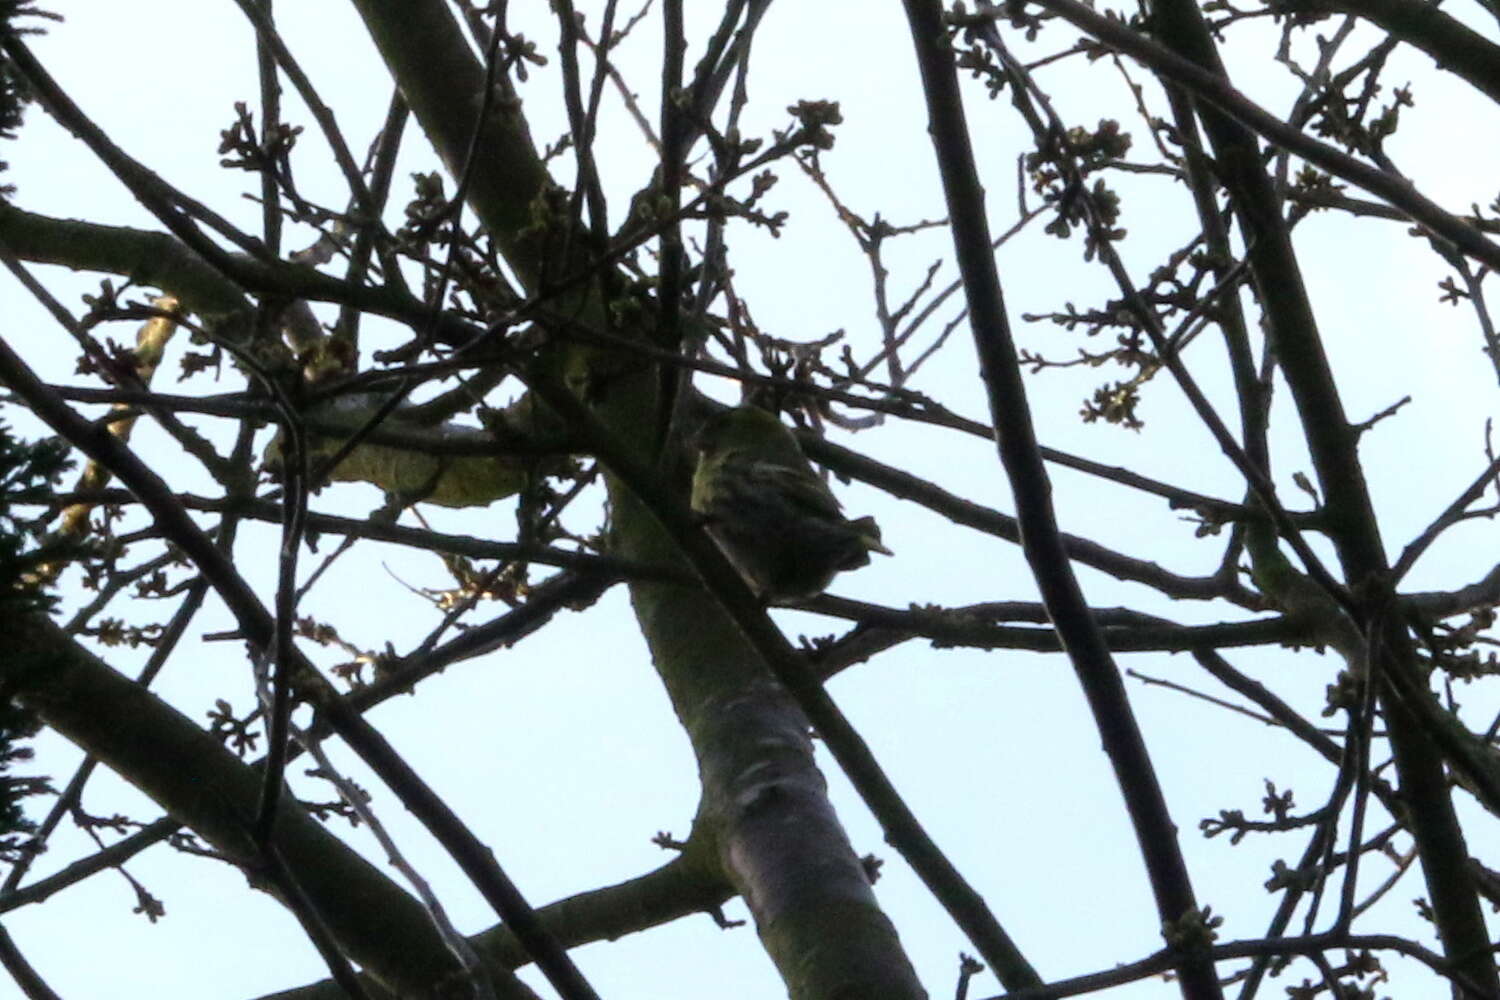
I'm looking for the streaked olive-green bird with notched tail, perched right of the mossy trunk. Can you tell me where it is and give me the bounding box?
[693,406,891,601]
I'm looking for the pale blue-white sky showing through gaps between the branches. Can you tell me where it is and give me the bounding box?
[0,0,1500,1000]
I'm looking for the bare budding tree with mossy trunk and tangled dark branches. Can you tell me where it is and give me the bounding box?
[0,0,1500,1000]
